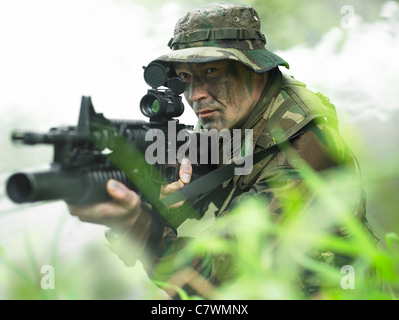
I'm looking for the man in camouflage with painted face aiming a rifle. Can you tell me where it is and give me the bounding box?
[69,3,376,296]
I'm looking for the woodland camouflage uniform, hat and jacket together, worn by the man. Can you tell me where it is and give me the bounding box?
[108,3,376,295]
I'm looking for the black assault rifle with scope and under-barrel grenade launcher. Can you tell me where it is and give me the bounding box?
[6,62,216,226]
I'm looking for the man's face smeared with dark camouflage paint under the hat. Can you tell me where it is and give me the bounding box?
[175,60,267,130]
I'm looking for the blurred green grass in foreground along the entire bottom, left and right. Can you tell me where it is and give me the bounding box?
[0,152,399,300]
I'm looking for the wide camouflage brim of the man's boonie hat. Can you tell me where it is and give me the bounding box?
[155,47,289,73]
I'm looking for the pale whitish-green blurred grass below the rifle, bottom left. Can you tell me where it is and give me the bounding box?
[0,222,159,300]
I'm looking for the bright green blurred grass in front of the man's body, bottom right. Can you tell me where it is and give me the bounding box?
[148,141,399,300]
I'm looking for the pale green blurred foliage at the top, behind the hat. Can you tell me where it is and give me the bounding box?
[132,0,386,50]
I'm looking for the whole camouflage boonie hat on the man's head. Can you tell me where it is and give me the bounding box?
[156,3,289,73]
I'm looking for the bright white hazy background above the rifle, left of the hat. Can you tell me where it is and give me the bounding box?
[0,0,195,128]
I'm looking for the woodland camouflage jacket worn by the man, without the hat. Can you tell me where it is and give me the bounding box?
[134,68,376,297]
